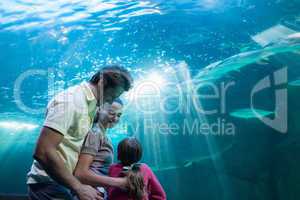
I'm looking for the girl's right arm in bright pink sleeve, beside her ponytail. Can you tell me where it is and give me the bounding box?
[146,165,167,200]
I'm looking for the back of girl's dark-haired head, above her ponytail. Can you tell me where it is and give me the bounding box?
[118,138,143,166]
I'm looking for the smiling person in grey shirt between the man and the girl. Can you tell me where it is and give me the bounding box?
[74,99,126,196]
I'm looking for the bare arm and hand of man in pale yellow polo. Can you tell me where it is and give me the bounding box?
[34,127,102,200]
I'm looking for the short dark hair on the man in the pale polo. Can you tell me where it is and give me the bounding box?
[90,65,133,91]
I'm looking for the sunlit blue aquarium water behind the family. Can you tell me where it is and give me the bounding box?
[0,0,300,200]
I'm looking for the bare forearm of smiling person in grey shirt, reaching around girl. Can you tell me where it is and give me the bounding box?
[74,153,127,188]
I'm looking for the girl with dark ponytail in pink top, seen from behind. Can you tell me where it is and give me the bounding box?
[108,138,166,200]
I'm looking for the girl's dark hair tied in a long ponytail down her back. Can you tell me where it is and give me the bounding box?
[118,138,145,200]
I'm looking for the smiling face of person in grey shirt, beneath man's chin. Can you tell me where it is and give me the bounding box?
[99,102,123,128]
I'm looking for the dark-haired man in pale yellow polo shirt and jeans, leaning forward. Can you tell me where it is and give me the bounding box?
[27,66,132,200]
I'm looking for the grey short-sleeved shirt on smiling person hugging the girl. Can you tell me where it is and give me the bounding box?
[81,124,113,175]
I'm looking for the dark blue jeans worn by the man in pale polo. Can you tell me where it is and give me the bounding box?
[28,182,73,200]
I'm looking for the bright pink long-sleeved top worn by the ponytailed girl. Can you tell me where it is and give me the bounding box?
[108,164,167,200]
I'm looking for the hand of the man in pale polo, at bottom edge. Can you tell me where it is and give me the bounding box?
[75,185,103,200]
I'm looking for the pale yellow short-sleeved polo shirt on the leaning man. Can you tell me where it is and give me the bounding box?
[27,82,97,184]
